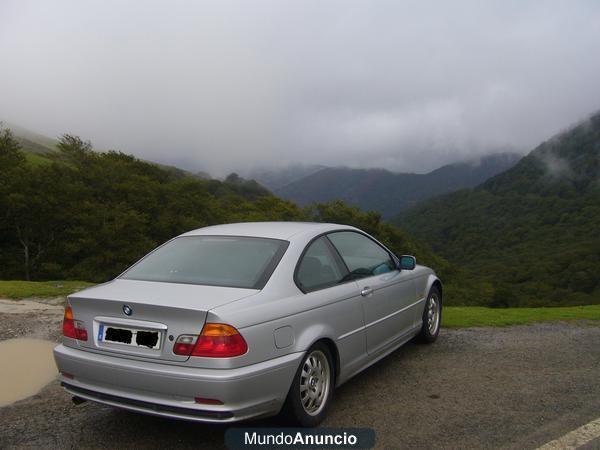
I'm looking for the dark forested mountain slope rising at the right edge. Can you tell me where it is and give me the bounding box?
[394,113,600,306]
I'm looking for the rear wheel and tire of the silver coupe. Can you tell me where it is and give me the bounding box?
[282,342,335,427]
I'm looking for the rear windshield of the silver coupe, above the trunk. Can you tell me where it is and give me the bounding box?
[121,236,288,289]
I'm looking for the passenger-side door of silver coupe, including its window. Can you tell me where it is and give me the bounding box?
[328,231,416,354]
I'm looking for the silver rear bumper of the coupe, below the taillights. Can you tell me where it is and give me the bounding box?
[54,345,303,422]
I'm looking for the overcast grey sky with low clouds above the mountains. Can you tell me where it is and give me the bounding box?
[0,0,600,175]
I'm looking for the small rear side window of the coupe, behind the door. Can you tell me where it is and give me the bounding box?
[296,237,342,292]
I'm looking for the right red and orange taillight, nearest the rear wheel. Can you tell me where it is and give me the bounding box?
[173,323,248,358]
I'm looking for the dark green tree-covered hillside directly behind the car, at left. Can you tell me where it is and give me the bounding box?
[0,125,448,282]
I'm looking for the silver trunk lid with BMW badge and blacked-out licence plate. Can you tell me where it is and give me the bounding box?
[68,279,259,361]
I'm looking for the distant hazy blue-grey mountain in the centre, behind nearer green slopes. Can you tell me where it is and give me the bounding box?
[268,153,520,218]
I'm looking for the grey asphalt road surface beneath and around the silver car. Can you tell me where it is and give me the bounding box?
[0,304,600,449]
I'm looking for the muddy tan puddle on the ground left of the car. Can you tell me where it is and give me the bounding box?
[0,339,58,406]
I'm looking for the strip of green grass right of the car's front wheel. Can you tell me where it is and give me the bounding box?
[442,305,600,328]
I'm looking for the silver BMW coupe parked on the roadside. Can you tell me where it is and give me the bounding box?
[54,222,442,426]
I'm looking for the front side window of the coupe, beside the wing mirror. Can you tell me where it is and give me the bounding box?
[328,231,395,279]
